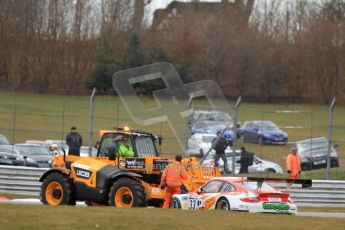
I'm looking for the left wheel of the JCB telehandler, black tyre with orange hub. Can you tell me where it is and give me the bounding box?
[40,173,75,206]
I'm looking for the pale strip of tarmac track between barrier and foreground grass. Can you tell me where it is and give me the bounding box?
[0,199,345,218]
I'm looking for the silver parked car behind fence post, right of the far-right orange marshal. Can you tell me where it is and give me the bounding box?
[296,137,339,170]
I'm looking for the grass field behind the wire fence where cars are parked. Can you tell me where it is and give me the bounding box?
[0,92,345,179]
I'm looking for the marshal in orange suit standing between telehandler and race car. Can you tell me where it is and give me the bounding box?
[161,155,188,208]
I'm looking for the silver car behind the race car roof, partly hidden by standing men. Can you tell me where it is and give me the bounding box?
[202,150,283,174]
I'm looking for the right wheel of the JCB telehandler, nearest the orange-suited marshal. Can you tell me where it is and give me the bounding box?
[108,177,147,208]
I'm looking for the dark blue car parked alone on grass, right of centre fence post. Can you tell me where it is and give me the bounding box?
[239,121,288,145]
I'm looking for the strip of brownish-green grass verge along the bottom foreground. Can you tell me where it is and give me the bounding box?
[0,204,345,230]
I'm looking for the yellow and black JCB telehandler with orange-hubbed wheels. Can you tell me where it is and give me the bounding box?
[40,128,220,207]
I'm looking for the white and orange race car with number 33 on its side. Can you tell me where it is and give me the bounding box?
[170,177,311,215]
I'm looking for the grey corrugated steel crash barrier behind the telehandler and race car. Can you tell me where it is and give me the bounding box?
[0,166,345,207]
